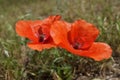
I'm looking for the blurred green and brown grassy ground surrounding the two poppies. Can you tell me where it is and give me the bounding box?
[0,0,120,80]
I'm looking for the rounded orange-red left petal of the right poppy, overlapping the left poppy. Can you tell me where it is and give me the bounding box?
[50,21,69,44]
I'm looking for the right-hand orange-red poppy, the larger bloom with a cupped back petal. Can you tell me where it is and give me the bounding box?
[50,20,112,61]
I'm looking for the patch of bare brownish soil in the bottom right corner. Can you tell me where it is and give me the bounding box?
[74,56,120,80]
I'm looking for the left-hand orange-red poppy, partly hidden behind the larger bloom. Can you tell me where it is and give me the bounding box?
[16,15,61,51]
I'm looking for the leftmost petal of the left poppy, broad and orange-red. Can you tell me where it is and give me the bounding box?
[16,20,38,42]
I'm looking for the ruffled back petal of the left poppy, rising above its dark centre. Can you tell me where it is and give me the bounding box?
[33,15,61,40]
